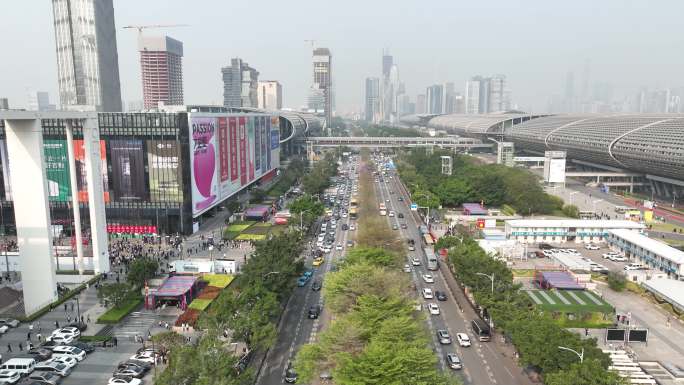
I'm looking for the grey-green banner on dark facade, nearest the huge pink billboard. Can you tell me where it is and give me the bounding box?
[147,140,183,202]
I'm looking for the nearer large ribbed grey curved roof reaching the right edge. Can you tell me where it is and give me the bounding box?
[505,114,684,180]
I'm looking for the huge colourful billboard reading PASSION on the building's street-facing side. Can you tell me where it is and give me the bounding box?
[187,113,280,217]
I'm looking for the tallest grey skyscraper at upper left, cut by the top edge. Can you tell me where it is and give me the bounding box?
[52,0,121,111]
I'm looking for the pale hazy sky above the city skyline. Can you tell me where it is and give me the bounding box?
[0,0,684,112]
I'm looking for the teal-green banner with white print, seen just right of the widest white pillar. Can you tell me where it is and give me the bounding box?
[43,139,71,202]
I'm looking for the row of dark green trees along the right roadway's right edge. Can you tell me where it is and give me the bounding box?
[440,234,624,385]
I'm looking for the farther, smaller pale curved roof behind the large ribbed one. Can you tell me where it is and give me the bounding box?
[428,111,543,136]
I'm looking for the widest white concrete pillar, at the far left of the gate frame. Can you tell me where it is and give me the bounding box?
[5,118,57,314]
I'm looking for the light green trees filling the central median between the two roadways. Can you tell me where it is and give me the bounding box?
[295,153,459,385]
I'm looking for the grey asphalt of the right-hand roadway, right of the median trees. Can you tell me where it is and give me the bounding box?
[376,157,532,385]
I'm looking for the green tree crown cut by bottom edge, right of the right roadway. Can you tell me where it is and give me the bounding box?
[544,359,627,385]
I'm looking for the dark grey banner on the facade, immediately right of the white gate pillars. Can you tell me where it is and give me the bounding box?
[109,139,147,202]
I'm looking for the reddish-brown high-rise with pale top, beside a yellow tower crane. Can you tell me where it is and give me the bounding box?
[138,35,183,109]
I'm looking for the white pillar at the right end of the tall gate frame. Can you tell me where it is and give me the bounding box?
[82,117,109,274]
